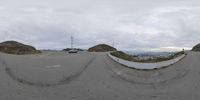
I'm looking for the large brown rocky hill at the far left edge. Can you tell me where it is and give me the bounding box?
[0,41,40,55]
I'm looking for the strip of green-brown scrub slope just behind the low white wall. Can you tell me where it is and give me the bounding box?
[111,51,185,63]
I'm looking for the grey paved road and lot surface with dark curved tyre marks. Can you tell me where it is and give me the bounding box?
[0,52,200,100]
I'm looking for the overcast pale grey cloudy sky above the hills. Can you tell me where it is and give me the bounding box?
[0,0,200,50]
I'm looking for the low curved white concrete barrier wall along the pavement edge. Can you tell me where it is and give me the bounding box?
[108,53,186,70]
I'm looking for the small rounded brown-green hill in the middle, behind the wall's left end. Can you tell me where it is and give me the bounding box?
[88,44,117,52]
